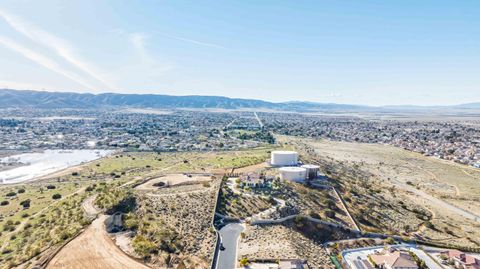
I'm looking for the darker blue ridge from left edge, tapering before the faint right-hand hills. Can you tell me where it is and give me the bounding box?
[0,89,368,111]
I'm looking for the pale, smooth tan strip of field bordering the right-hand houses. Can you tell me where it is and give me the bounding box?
[311,140,480,203]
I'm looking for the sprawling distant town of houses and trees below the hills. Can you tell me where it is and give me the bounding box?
[0,109,480,168]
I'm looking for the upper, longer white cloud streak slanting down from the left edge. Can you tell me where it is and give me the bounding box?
[0,9,116,89]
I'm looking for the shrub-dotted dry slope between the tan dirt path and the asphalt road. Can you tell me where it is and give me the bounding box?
[134,182,218,268]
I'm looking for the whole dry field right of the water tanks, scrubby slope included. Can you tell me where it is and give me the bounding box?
[283,137,480,246]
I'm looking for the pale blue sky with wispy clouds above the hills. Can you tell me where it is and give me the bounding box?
[0,0,480,105]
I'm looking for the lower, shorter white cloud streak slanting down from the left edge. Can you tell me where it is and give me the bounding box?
[0,36,95,90]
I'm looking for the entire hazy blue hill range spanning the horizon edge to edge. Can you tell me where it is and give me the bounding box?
[0,89,480,114]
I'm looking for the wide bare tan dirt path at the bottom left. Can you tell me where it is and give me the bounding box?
[46,215,150,269]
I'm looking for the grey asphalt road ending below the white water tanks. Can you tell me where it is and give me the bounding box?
[217,223,245,269]
